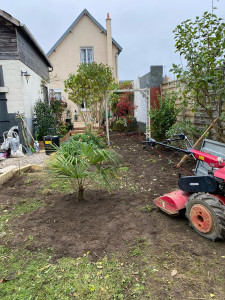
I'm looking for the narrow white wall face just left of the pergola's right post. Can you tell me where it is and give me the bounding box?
[133,78,146,124]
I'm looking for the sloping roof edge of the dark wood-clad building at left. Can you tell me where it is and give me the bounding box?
[0,9,53,68]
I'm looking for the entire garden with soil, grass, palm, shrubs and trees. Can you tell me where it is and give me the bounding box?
[0,7,225,300]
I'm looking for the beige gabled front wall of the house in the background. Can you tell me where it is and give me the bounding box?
[49,15,118,112]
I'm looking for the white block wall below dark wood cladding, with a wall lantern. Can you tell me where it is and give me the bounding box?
[0,60,46,139]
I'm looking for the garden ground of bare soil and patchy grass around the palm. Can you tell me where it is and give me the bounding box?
[0,133,225,299]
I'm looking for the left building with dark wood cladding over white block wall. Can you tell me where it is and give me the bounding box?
[0,10,52,142]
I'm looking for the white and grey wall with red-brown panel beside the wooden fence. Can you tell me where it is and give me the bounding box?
[133,66,163,131]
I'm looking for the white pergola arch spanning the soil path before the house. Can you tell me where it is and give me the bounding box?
[105,88,151,145]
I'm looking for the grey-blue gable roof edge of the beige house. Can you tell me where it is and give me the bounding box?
[47,8,123,56]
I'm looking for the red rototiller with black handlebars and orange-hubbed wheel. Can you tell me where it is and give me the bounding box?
[143,133,225,241]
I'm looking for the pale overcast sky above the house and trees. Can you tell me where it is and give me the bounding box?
[0,0,225,80]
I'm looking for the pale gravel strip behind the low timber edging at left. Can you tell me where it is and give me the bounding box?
[0,152,48,169]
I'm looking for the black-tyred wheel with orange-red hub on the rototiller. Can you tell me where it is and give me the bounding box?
[185,193,225,241]
